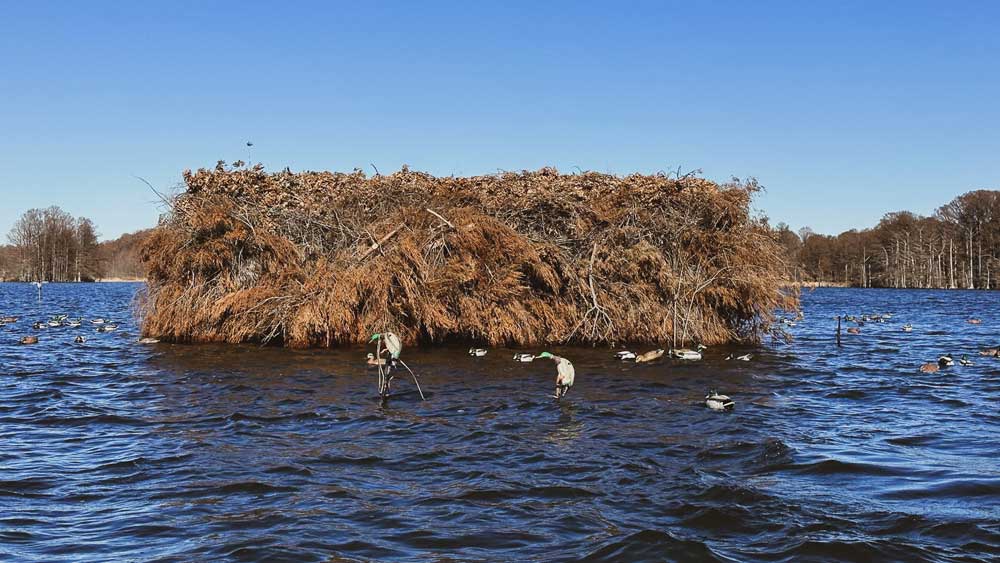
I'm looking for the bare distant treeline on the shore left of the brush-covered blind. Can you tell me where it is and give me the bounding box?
[0,206,148,282]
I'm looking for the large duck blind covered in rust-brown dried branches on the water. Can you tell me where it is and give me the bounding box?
[141,162,797,347]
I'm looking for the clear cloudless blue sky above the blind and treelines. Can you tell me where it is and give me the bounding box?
[0,0,1000,238]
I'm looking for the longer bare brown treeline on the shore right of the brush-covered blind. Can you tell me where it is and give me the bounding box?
[776,190,1000,289]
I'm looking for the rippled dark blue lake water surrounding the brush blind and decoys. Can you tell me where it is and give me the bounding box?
[0,284,1000,562]
